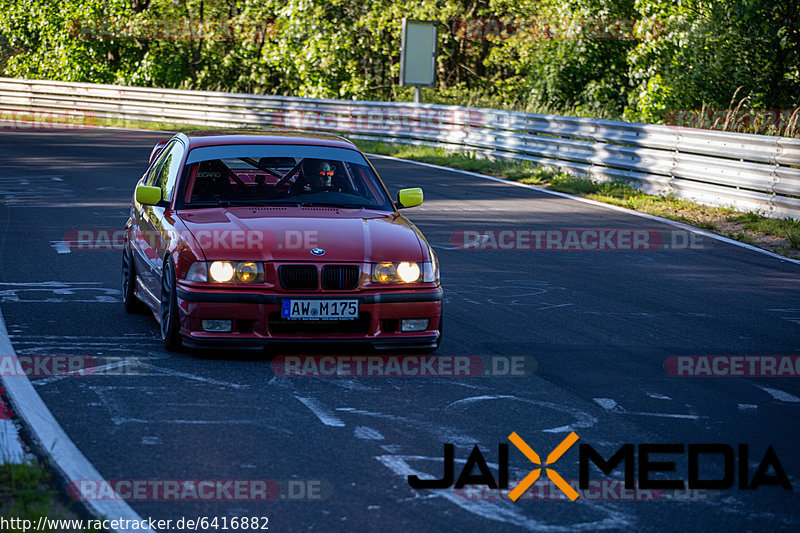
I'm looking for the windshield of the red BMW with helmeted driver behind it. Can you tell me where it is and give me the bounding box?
[181,145,394,211]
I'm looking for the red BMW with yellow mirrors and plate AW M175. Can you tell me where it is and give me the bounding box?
[122,131,442,350]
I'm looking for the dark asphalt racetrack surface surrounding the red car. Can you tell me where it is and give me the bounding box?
[0,125,800,531]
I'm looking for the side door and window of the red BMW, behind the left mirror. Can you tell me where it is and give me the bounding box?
[135,139,185,299]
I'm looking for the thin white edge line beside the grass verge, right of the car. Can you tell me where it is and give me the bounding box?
[366,154,800,265]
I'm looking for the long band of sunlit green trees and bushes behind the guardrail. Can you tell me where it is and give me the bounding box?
[0,0,800,129]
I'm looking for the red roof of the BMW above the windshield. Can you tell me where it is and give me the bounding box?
[181,129,355,150]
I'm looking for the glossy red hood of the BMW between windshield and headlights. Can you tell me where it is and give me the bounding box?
[177,207,428,263]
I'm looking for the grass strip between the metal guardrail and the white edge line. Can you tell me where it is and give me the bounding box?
[356,141,800,259]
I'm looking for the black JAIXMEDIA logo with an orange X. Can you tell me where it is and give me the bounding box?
[408,432,792,501]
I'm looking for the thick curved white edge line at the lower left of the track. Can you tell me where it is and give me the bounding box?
[0,306,154,533]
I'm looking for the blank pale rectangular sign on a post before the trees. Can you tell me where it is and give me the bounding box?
[400,18,438,102]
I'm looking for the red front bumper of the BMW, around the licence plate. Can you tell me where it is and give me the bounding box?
[177,282,442,348]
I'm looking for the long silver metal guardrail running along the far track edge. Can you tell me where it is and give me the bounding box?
[0,78,800,218]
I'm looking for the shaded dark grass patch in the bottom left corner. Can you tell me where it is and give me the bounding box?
[0,462,95,533]
